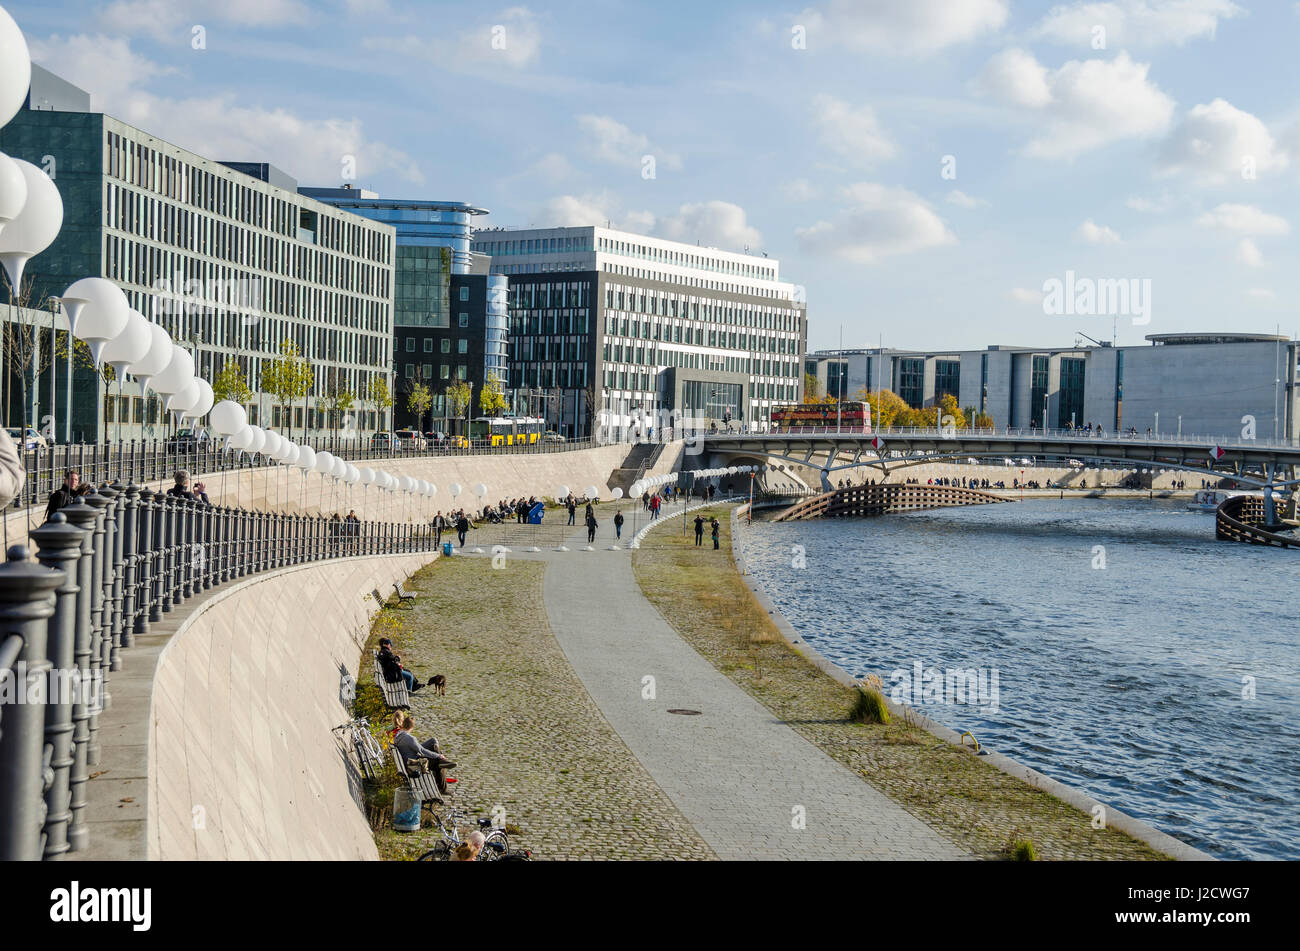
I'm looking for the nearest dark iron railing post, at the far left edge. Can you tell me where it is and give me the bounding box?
[0,544,64,861]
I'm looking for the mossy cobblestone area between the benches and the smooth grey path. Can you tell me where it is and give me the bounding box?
[385,552,714,860]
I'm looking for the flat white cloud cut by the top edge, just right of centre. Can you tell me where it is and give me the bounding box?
[800,0,1008,56]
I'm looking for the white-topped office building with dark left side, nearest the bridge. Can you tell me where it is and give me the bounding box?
[473,226,807,437]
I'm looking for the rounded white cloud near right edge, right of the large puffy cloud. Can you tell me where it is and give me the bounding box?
[1160,99,1287,183]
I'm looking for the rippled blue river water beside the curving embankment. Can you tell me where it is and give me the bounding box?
[745,499,1300,859]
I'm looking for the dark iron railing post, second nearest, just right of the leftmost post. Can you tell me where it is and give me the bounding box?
[31,512,90,859]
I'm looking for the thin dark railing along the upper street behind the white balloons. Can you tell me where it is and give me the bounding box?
[12,438,605,508]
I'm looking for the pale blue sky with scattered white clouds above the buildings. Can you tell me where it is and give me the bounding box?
[10,0,1300,349]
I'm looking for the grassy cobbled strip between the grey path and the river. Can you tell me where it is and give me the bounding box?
[633,505,1167,860]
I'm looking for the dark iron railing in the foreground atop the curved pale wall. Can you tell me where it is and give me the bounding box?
[0,483,434,860]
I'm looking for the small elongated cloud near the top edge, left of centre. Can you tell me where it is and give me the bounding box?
[361,6,542,75]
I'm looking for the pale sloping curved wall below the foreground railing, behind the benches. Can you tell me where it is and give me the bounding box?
[147,553,430,860]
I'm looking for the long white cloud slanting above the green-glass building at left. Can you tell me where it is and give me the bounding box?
[31,36,424,184]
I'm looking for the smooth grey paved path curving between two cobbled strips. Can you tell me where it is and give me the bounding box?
[460,521,969,859]
